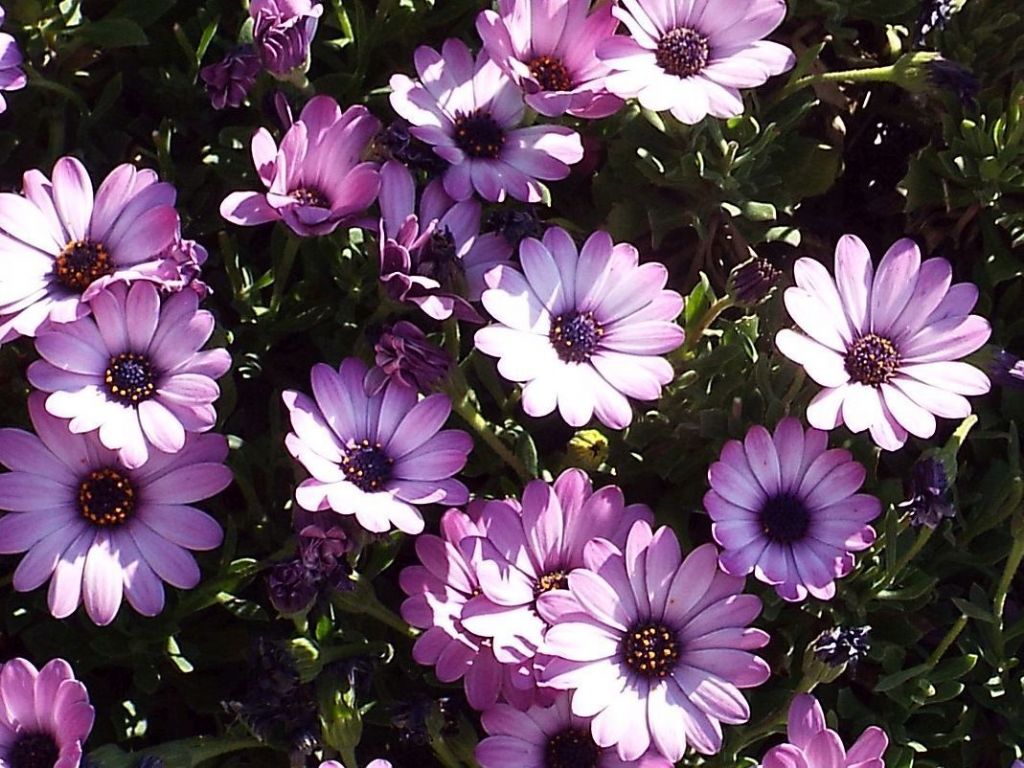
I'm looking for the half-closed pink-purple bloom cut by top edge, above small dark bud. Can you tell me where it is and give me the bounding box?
[249,0,324,78]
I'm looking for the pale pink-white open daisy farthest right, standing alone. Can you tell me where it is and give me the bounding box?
[775,234,992,451]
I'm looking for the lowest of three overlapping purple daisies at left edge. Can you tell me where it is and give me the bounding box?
[0,393,231,625]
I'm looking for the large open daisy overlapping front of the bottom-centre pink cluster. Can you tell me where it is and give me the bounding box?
[538,521,771,763]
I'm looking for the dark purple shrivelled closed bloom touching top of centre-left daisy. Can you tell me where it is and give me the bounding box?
[367,321,452,393]
